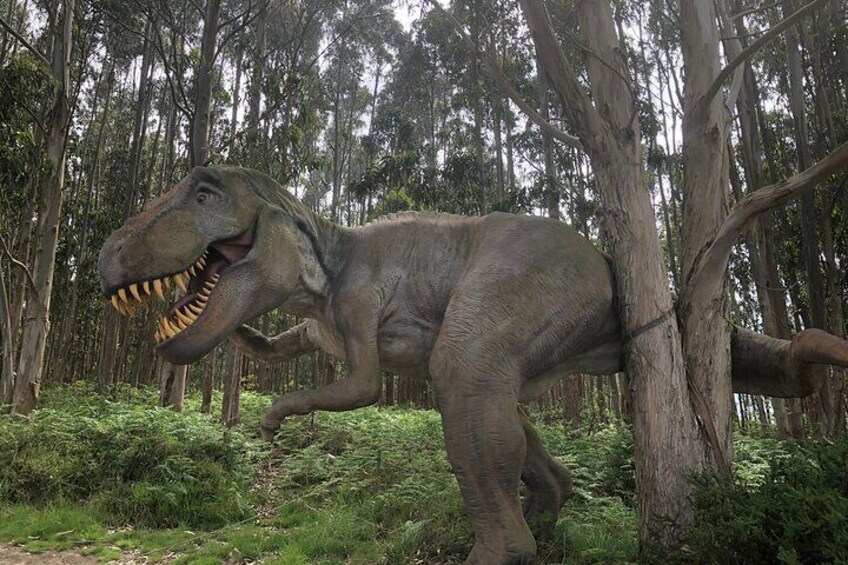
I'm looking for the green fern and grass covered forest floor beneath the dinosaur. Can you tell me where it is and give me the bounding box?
[0,385,848,565]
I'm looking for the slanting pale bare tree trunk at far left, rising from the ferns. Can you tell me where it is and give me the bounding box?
[12,0,74,414]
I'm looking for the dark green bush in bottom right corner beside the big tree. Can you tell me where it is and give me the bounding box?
[683,437,848,563]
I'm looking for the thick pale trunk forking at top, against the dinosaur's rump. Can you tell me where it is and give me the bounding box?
[522,0,704,546]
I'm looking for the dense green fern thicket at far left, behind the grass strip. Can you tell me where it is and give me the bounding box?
[0,387,255,527]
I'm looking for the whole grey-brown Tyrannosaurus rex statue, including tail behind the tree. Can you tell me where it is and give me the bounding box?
[100,167,848,564]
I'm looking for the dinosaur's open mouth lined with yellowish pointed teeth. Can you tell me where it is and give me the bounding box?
[104,228,253,344]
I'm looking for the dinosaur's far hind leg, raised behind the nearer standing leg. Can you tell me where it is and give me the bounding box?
[519,408,571,538]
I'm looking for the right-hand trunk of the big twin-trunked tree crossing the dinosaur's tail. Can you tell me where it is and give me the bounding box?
[679,0,733,473]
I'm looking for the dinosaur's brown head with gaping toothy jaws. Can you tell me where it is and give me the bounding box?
[100,167,301,364]
